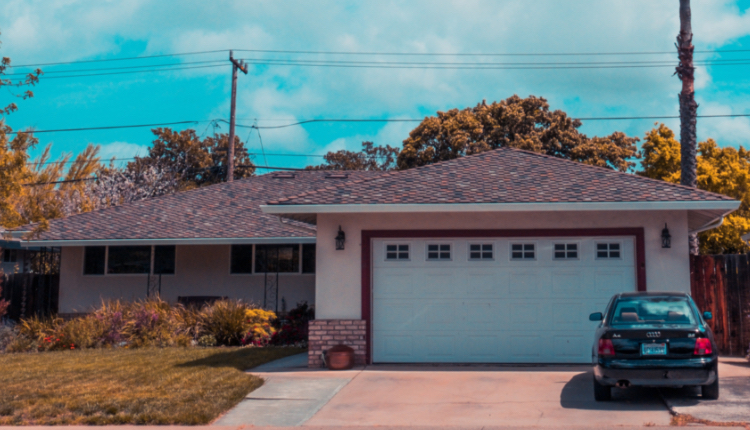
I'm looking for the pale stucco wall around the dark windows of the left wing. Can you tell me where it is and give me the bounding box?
[59,245,315,313]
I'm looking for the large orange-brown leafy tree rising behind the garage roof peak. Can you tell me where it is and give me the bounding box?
[397,95,639,171]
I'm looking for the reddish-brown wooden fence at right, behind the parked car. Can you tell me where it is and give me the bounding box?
[690,254,750,356]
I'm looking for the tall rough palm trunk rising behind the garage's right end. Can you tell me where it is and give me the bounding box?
[675,0,698,255]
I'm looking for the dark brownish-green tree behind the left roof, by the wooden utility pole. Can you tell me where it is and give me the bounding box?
[127,128,255,190]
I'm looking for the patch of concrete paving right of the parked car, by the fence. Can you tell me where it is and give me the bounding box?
[662,358,750,423]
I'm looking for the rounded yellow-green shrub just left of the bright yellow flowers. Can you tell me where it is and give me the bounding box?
[200,300,252,346]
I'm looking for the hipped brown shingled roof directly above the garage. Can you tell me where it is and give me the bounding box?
[268,148,733,207]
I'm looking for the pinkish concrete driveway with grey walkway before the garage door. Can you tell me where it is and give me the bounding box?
[214,358,671,428]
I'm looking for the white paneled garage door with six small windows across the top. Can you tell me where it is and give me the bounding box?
[372,237,636,363]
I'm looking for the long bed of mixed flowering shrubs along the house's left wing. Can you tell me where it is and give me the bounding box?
[0,298,312,352]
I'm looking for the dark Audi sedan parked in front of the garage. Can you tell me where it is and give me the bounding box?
[589,293,719,401]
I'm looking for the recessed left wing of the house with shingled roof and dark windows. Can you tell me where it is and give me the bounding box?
[16,171,382,315]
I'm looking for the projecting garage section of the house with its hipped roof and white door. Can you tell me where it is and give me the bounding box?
[262,148,739,366]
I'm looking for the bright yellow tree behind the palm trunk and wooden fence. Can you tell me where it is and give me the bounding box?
[638,124,750,254]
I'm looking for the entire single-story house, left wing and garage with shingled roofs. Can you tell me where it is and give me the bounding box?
[13,148,739,366]
